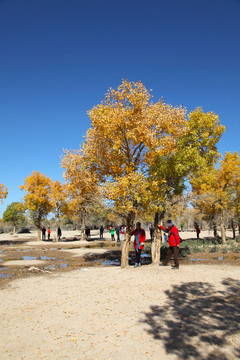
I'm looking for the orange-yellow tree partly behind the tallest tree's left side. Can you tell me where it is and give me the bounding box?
[61,149,101,240]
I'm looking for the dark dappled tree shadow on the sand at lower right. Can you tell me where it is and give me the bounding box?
[142,278,240,360]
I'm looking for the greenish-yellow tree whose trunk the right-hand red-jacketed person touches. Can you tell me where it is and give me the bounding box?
[149,108,225,263]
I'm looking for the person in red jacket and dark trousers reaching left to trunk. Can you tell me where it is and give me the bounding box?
[159,220,180,269]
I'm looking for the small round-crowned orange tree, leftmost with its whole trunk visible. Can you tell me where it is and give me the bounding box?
[19,171,53,240]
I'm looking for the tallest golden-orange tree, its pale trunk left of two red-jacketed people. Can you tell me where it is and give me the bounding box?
[84,81,186,267]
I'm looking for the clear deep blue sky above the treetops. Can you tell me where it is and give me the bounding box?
[0,0,240,217]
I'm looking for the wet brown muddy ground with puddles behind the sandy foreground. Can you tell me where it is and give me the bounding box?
[0,239,240,287]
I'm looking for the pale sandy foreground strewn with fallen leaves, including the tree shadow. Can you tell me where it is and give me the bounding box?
[0,265,240,360]
